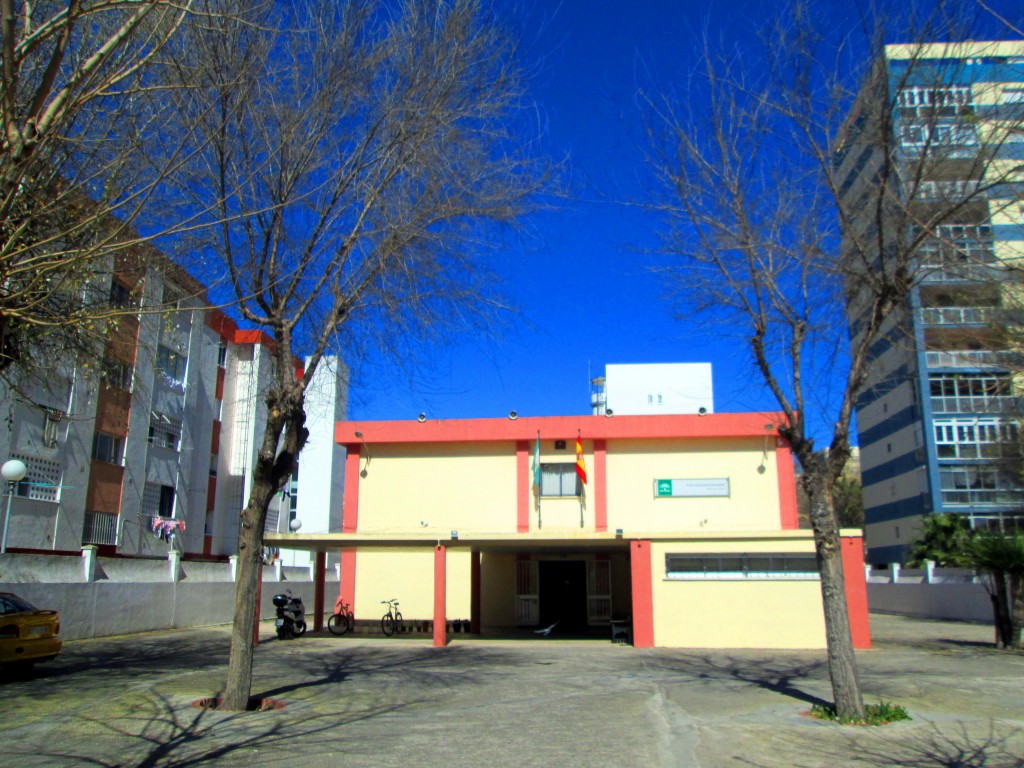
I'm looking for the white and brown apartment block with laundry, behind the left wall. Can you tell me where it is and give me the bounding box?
[0,260,347,564]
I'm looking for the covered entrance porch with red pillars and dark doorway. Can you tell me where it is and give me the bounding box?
[267,531,653,647]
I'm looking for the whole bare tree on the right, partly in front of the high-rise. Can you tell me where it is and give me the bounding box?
[644,3,1021,720]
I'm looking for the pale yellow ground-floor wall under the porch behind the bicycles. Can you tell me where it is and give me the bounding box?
[355,547,471,622]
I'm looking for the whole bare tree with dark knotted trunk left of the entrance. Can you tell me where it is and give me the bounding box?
[160,0,549,710]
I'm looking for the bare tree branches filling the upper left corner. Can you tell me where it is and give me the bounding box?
[0,0,208,387]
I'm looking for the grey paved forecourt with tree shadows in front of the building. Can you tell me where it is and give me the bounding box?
[0,615,1024,768]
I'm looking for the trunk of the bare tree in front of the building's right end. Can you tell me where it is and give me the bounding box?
[804,473,864,720]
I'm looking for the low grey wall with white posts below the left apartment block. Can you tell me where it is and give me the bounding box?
[0,547,338,640]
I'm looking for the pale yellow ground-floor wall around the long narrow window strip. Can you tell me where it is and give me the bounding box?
[651,540,825,648]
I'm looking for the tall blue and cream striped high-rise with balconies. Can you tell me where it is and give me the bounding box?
[837,42,1024,564]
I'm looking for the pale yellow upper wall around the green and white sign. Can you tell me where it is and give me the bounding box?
[607,437,780,538]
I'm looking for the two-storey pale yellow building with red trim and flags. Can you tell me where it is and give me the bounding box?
[267,414,870,648]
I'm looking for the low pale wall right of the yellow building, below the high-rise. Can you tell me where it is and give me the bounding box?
[865,563,992,622]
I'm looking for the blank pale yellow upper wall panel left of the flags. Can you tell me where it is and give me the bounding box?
[358,443,516,539]
